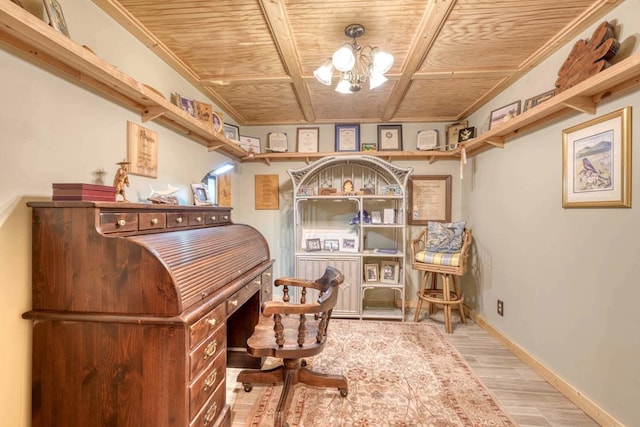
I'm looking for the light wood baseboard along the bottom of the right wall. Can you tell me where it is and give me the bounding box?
[465,306,624,427]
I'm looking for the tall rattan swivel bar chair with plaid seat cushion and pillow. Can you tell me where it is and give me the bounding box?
[411,223,473,334]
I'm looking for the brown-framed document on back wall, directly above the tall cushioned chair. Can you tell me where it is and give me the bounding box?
[408,175,451,225]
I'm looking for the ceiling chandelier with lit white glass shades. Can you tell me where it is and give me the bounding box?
[313,24,393,94]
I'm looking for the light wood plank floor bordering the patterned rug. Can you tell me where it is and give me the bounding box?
[227,313,599,427]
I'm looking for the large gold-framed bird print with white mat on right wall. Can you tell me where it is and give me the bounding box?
[562,107,631,208]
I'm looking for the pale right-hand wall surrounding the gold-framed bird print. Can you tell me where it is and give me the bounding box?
[462,0,640,426]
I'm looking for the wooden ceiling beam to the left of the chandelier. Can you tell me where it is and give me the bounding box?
[259,0,316,123]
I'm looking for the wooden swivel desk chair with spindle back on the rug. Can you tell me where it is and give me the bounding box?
[237,267,348,427]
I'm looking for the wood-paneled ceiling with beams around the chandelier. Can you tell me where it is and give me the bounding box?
[94,0,623,125]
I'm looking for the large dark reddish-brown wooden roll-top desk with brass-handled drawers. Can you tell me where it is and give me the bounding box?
[23,202,272,427]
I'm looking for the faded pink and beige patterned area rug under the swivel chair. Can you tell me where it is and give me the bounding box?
[249,319,516,427]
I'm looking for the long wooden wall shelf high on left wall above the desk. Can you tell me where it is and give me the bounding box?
[0,1,247,160]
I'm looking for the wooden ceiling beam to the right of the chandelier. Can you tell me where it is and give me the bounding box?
[382,0,457,122]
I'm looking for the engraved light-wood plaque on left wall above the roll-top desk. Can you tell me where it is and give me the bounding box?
[127,122,158,178]
